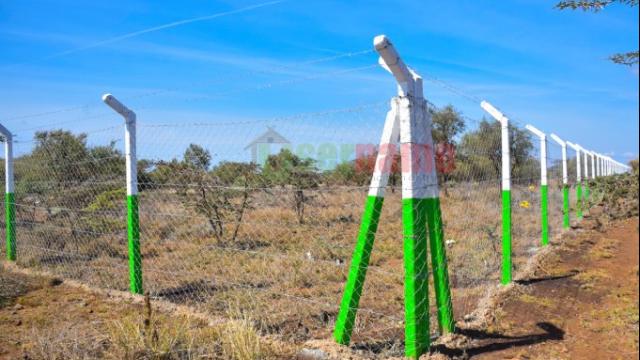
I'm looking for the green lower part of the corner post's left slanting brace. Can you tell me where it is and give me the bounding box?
[333,196,384,345]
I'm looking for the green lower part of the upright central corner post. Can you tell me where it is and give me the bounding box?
[402,199,430,359]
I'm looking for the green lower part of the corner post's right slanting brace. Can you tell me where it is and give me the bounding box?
[424,198,455,334]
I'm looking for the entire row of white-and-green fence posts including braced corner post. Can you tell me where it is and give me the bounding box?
[0,35,629,358]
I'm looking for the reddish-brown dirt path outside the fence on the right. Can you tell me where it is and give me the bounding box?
[449,217,639,359]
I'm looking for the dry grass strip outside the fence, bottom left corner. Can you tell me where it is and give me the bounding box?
[0,265,295,360]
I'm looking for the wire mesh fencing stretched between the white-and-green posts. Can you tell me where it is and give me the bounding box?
[0,66,596,354]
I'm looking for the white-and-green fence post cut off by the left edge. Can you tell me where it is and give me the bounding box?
[0,125,16,261]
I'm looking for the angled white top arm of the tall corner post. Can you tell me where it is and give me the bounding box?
[373,35,423,98]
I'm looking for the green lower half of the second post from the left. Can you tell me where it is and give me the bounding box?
[127,195,143,294]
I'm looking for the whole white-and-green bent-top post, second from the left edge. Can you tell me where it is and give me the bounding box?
[102,94,143,294]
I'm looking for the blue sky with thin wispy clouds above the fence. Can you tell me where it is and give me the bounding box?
[0,0,639,162]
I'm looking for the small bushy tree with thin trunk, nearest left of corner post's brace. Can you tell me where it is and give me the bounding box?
[262,149,320,224]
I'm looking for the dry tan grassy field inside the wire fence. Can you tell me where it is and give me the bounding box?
[2,181,576,357]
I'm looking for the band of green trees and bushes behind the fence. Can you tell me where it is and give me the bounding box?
[0,115,539,248]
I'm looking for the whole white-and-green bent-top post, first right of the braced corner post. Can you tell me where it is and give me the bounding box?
[480,101,513,285]
